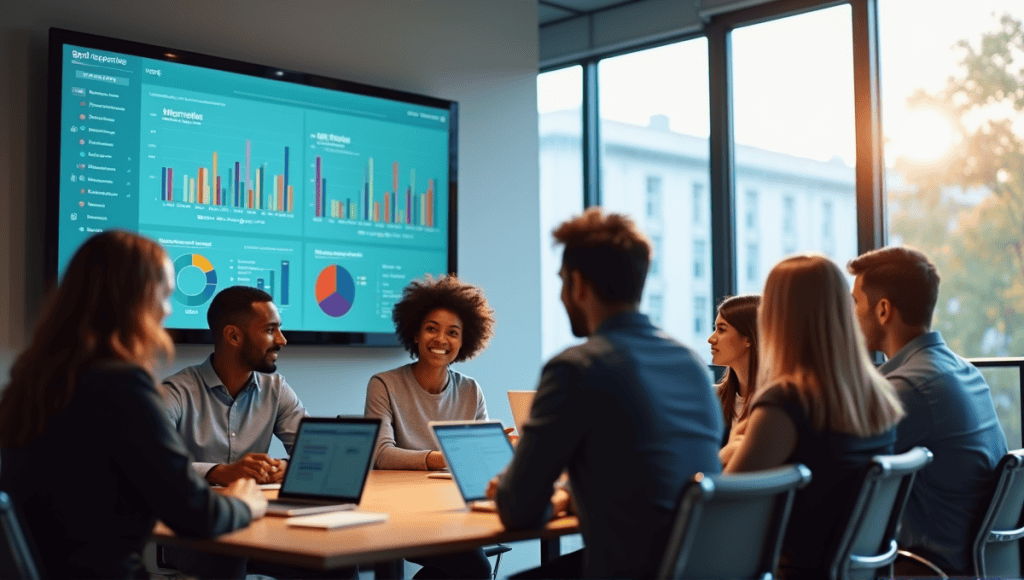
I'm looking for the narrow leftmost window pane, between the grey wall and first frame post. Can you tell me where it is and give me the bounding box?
[537,67,583,359]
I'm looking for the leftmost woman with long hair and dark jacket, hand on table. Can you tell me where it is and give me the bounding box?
[0,231,266,578]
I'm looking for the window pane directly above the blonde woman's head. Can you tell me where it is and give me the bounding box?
[732,0,860,293]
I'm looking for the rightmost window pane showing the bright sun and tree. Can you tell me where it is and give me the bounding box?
[879,0,1024,444]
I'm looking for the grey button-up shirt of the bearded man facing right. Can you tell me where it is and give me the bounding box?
[161,355,309,478]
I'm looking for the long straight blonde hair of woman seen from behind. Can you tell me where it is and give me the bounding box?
[757,254,903,437]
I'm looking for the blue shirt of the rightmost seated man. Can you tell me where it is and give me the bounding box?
[879,332,1007,573]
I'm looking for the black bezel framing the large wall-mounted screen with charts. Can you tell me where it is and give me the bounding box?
[44,28,459,346]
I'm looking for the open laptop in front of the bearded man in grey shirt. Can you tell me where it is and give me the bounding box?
[266,417,381,515]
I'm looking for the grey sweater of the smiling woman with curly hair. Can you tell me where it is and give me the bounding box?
[364,363,487,469]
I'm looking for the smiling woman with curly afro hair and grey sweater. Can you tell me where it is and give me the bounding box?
[365,275,495,579]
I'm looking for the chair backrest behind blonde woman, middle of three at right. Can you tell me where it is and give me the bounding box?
[829,447,932,580]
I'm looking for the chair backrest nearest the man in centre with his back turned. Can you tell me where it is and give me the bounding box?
[657,464,811,580]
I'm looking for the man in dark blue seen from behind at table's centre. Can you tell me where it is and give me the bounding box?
[488,208,722,578]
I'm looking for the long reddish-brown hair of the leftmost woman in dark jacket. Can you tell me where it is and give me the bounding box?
[0,231,174,448]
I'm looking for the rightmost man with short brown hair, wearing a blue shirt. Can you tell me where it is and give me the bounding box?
[847,247,1007,574]
